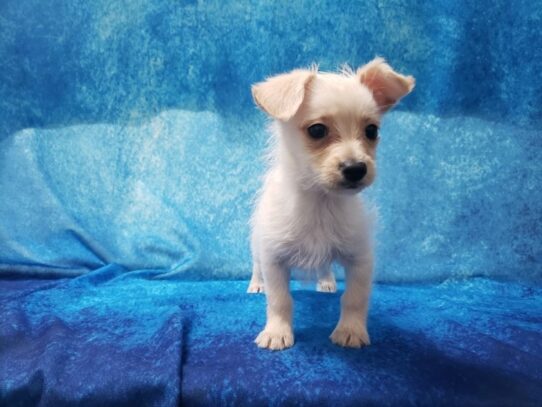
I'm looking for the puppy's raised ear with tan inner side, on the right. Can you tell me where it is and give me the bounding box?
[356,58,415,112]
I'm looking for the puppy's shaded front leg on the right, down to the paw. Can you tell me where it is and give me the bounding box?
[330,259,373,348]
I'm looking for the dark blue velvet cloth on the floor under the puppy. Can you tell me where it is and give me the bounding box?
[0,266,542,406]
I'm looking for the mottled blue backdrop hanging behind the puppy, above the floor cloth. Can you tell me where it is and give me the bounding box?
[0,0,542,281]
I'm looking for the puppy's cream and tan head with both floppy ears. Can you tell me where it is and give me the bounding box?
[252,58,414,192]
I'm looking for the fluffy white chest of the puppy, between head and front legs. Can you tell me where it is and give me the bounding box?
[253,171,365,269]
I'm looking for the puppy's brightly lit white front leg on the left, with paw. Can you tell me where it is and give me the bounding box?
[255,262,294,350]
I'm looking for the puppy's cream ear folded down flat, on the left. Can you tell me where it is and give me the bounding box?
[252,69,316,121]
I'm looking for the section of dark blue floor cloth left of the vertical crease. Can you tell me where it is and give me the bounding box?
[0,265,190,406]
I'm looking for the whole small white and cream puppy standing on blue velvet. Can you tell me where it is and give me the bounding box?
[248,58,414,350]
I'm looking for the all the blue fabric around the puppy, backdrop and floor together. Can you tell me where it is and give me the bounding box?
[0,0,542,406]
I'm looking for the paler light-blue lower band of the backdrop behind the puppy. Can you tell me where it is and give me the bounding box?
[0,110,542,281]
